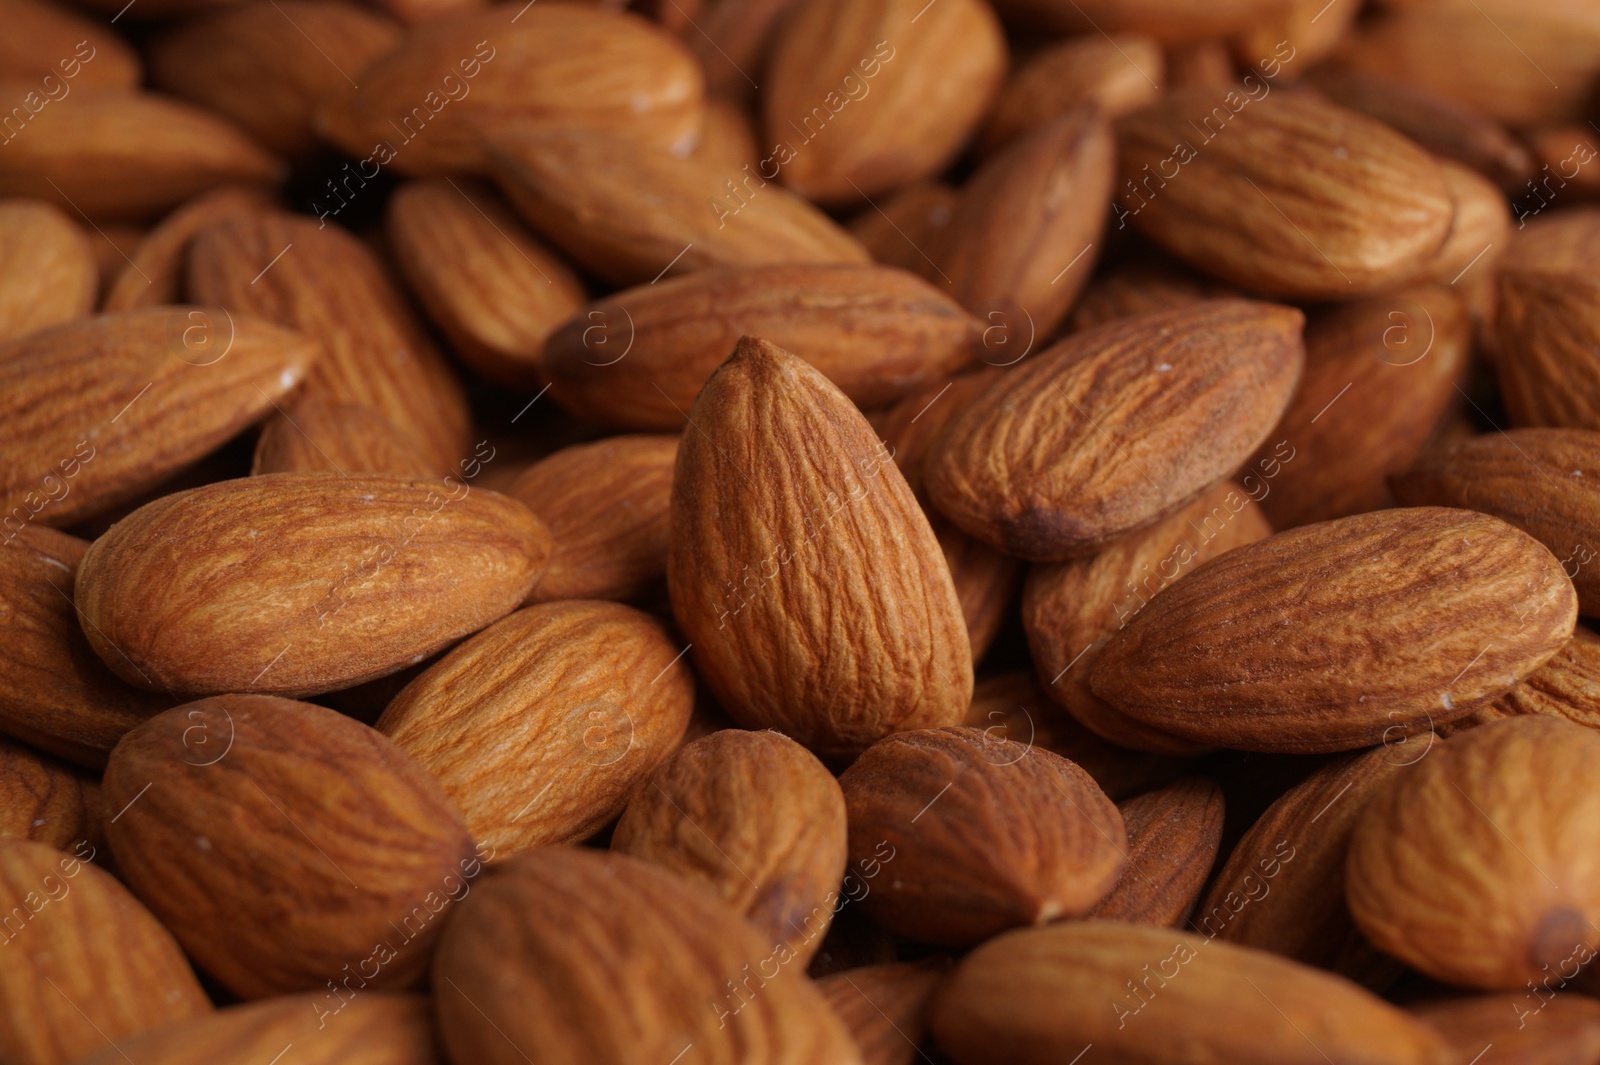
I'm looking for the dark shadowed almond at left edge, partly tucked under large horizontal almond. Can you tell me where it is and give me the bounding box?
[0,526,173,757]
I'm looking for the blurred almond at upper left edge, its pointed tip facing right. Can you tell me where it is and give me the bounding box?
[0,89,278,221]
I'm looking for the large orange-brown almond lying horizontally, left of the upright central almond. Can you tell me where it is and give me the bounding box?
[75,473,550,696]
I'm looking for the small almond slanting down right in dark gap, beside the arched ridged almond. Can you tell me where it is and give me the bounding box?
[386,178,584,392]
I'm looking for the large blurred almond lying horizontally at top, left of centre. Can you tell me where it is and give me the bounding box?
[318,3,706,176]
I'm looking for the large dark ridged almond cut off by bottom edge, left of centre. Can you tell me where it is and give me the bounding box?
[434,848,861,1065]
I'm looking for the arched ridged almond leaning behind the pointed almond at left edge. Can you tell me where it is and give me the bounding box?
[189,213,469,473]
